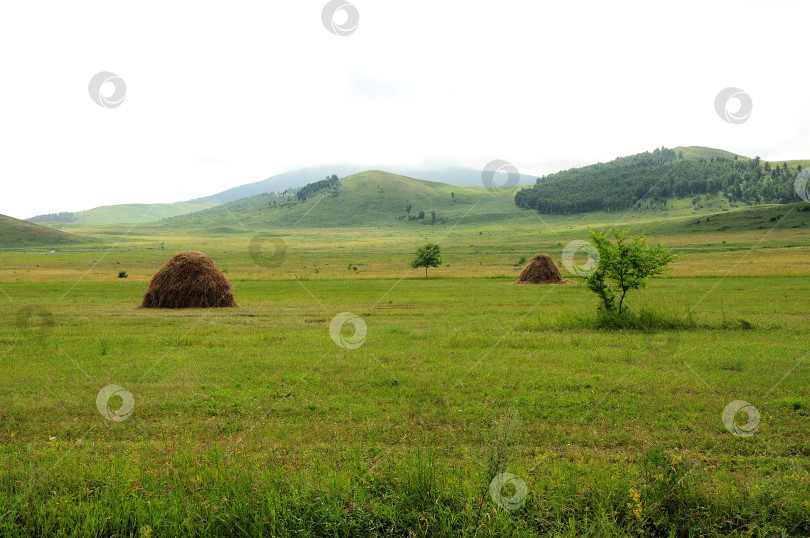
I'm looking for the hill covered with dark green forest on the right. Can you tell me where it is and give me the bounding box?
[515,147,801,214]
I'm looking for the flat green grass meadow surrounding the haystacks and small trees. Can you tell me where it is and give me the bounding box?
[0,219,810,536]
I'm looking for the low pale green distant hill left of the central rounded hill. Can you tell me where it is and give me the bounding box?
[26,201,217,224]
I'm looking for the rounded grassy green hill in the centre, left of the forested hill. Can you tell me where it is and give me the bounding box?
[153,170,536,231]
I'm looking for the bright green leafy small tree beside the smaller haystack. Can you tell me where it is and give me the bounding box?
[588,230,678,314]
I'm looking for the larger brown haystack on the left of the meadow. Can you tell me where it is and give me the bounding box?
[141,252,237,308]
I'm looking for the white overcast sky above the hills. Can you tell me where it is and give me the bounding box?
[0,0,810,218]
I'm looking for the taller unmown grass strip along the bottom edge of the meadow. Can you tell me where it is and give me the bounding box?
[0,447,810,537]
